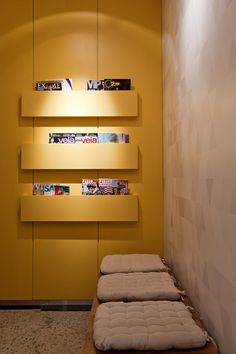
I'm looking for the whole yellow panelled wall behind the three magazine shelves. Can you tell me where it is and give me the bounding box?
[0,0,162,299]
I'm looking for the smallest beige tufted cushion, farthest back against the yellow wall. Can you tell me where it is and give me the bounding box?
[100,254,167,274]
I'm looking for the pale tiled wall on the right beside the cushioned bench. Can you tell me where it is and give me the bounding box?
[163,0,236,354]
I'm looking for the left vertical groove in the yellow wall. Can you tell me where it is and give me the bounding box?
[32,0,35,299]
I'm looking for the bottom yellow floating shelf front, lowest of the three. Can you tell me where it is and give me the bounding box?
[21,195,138,222]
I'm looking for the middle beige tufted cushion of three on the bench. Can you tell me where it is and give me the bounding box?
[97,272,181,302]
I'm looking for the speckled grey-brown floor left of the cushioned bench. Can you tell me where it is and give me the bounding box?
[0,310,90,354]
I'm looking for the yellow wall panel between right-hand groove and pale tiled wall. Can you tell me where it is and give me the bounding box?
[98,0,163,259]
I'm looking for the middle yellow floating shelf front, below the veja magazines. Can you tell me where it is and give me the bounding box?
[21,143,138,170]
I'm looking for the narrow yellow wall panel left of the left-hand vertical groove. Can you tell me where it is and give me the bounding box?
[0,0,33,299]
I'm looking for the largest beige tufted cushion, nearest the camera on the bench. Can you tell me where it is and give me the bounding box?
[93,301,206,351]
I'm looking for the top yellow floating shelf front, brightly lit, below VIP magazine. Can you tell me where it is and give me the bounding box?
[21,90,138,117]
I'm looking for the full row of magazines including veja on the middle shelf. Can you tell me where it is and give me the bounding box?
[48,133,129,144]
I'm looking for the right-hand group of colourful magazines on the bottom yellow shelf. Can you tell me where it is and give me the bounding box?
[82,178,128,195]
